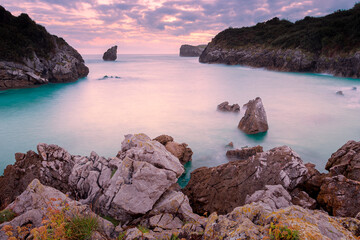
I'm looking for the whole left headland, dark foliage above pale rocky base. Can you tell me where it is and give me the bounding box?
[0,6,89,90]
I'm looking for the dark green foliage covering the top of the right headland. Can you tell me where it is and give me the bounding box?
[211,3,360,55]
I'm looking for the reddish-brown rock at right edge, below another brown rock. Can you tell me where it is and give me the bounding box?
[317,175,360,217]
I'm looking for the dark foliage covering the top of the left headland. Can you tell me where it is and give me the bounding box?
[0,6,58,62]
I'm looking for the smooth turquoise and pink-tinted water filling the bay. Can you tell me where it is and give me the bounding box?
[0,55,360,186]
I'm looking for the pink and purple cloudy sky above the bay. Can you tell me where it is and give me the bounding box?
[0,0,359,54]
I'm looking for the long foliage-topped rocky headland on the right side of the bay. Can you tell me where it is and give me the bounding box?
[199,3,360,78]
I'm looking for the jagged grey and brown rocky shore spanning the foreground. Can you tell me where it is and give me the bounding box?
[0,134,360,240]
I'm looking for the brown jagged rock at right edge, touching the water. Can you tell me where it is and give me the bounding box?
[325,141,360,181]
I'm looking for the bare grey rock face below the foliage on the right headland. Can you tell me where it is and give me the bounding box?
[199,43,360,78]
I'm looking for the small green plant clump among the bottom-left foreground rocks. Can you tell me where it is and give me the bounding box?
[65,216,98,240]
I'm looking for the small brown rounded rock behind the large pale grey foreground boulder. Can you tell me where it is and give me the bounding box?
[154,135,193,164]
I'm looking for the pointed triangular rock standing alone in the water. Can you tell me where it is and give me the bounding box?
[238,97,269,134]
